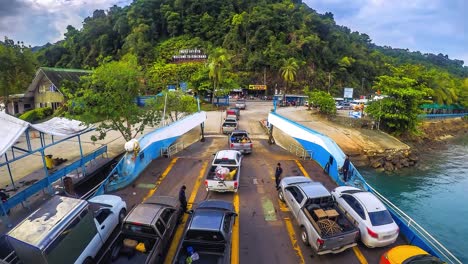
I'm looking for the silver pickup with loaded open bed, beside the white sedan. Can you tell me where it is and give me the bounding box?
[278,176,359,255]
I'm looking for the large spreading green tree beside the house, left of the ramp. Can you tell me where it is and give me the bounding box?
[66,55,160,141]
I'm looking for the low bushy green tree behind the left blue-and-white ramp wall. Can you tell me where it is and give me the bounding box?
[149,90,197,122]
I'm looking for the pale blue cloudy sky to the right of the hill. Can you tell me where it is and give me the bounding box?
[304,0,468,65]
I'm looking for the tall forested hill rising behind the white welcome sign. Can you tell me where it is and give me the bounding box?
[22,0,467,96]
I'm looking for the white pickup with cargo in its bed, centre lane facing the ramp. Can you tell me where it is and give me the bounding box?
[205,150,242,192]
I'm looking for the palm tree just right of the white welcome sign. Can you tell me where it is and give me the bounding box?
[208,48,231,103]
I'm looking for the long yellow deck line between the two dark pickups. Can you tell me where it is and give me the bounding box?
[164,161,208,264]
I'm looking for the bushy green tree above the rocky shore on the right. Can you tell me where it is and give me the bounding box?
[366,67,430,135]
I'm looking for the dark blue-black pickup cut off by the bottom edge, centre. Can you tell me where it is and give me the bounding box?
[172,200,237,264]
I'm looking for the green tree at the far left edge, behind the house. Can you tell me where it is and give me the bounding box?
[0,37,37,113]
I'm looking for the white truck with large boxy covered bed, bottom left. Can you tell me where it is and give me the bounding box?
[7,195,127,264]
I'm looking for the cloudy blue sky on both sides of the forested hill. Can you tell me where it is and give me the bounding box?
[0,0,468,65]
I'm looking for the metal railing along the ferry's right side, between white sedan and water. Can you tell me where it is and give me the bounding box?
[367,184,462,264]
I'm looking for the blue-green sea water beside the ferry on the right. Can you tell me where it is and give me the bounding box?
[359,135,468,263]
